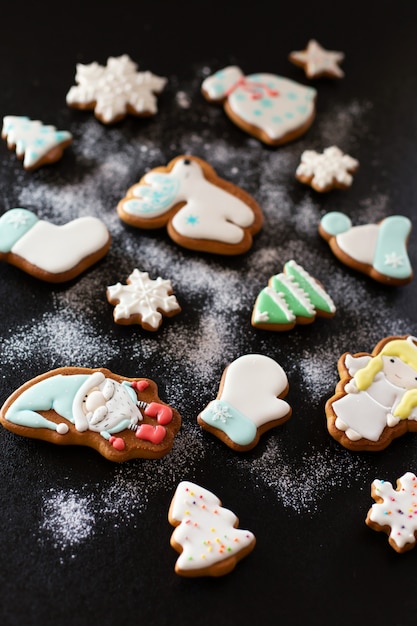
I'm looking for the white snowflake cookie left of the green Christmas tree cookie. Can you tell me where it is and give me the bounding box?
[107,269,181,331]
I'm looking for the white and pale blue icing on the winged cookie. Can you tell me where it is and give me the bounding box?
[128,158,255,244]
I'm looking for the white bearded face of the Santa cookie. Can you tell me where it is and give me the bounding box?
[84,378,142,432]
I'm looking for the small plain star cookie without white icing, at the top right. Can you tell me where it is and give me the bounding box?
[288,39,345,78]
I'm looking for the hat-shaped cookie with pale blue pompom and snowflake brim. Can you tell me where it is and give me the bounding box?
[319,211,413,286]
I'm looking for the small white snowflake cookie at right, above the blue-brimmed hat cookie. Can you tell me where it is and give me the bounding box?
[295,146,359,192]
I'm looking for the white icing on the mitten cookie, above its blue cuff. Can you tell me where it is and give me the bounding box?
[214,354,290,428]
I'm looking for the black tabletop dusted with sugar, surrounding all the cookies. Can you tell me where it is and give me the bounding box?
[0,1,417,626]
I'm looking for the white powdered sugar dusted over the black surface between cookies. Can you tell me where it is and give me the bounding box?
[1,68,410,555]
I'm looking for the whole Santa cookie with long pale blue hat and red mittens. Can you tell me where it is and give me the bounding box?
[0,367,181,462]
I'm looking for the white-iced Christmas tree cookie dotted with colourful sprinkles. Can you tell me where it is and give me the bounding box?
[168,481,256,577]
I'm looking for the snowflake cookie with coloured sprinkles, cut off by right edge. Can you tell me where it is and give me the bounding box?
[365,472,417,552]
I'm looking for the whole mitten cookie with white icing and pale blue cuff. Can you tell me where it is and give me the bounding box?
[197,354,292,452]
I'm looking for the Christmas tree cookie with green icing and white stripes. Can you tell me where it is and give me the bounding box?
[251,260,336,331]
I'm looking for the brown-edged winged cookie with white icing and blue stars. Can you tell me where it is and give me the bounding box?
[117,156,263,255]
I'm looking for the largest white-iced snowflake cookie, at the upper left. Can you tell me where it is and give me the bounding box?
[66,54,167,124]
